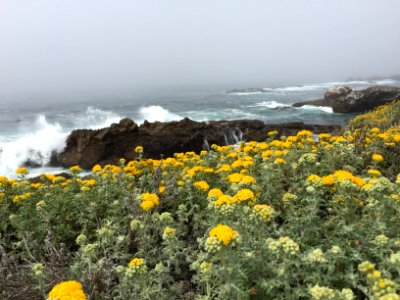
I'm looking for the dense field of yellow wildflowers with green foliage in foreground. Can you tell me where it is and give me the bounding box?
[0,104,400,300]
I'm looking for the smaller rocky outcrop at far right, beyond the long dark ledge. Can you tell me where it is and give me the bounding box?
[293,86,400,113]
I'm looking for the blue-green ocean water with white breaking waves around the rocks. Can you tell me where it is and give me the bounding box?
[0,79,400,178]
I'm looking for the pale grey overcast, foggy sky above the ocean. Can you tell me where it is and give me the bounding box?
[0,0,400,94]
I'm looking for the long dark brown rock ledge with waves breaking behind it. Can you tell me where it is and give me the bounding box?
[53,118,341,169]
